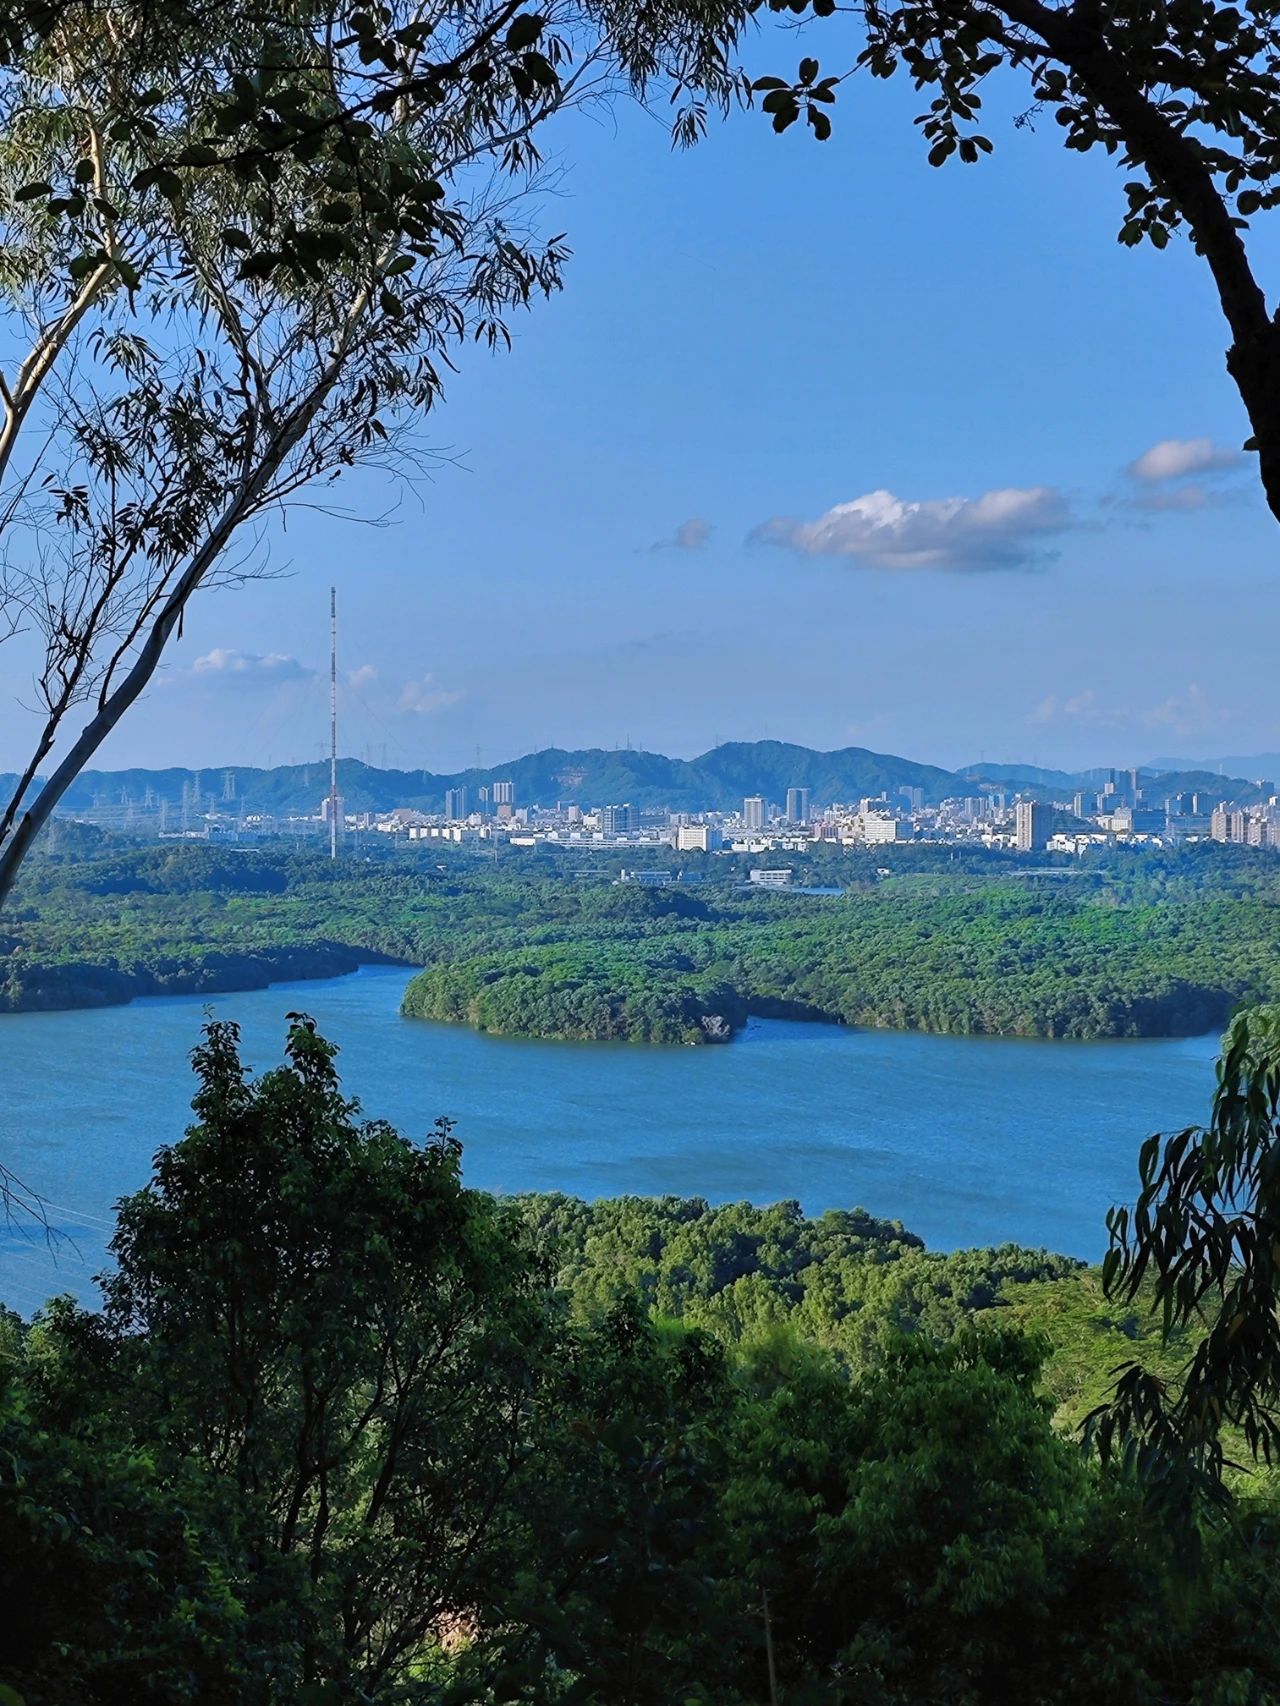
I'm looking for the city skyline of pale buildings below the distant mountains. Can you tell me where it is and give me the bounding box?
[42,749,1280,853]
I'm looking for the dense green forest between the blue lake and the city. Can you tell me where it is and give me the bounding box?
[10,838,1280,1042]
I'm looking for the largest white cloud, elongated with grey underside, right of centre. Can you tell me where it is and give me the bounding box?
[751,486,1072,572]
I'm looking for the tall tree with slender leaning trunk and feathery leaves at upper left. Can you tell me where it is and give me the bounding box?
[0,0,750,899]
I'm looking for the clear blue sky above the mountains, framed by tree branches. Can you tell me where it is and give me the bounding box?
[12,43,1280,769]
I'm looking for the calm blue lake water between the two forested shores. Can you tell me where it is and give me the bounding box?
[0,967,1217,1310]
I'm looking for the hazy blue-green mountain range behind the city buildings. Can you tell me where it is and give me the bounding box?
[0,740,1280,815]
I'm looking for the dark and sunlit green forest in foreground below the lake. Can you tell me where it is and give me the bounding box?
[0,1018,1280,1706]
